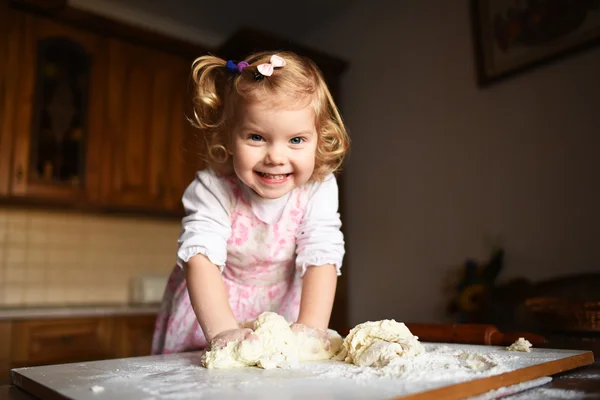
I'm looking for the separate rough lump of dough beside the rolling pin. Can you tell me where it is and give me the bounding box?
[335,319,425,367]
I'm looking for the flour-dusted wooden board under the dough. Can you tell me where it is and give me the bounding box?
[12,343,594,400]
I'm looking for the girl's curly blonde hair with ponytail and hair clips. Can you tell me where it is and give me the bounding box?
[192,52,350,181]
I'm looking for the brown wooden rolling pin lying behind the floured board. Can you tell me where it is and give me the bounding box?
[406,323,546,346]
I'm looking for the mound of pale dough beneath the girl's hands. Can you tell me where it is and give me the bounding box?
[202,312,342,369]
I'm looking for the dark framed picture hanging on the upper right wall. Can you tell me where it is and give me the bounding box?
[471,0,600,86]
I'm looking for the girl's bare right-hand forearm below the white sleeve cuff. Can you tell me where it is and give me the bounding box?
[297,264,337,329]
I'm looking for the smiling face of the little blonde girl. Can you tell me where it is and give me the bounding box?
[231,102,318,199]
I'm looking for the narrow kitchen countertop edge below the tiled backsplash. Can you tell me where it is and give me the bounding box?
[0,304,160,320]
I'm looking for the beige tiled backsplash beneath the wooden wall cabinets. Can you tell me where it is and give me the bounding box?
[0,208,181,306]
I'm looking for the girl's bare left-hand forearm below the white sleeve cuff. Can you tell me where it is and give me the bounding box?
[185,254,239,343]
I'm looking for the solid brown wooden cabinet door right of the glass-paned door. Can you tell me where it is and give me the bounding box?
[103,40,173,209]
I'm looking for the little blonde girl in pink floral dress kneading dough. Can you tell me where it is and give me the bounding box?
[152,52,349,354]
